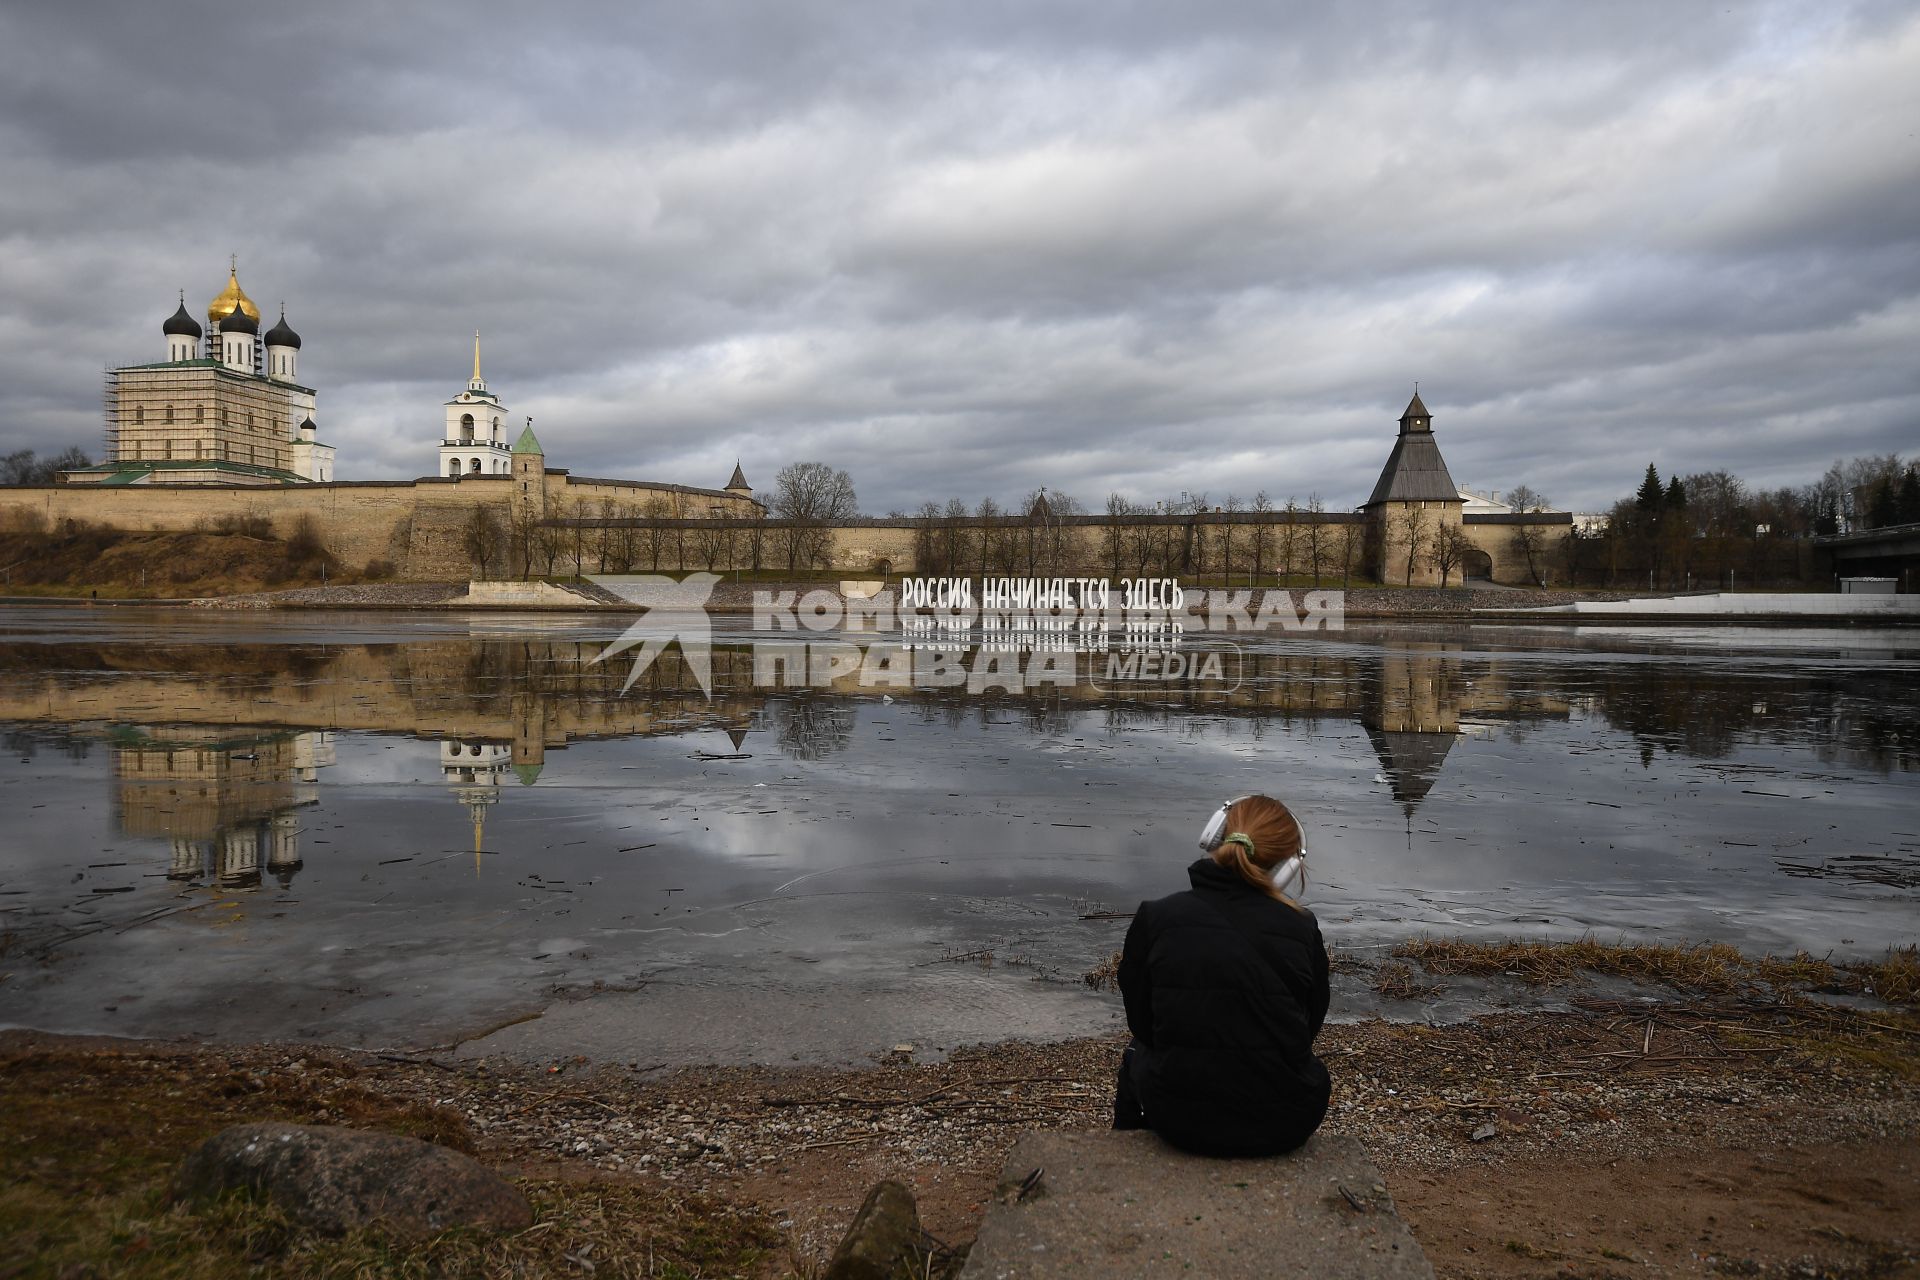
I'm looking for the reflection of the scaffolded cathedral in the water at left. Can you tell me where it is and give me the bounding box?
[113,725,334,889]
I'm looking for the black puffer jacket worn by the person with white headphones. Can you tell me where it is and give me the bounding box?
[1119,858,1331,1155]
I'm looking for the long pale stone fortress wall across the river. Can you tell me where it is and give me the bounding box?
[0,470,1571,585]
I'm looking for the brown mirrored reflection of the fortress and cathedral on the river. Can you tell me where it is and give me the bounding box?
[0,625,1920,887]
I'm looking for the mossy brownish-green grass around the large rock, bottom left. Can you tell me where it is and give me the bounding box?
[0,1050,780,1280]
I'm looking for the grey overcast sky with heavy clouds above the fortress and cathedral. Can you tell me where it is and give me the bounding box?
[0,0,1920,512]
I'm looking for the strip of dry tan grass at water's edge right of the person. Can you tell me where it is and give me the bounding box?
[1377,936,1920,1004]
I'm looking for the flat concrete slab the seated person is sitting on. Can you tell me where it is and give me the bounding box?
[960,1130,1434,1280]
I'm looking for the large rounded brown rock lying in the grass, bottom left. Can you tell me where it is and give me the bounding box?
[173,1125,534,1240]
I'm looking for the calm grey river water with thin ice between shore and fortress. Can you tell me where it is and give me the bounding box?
[0,608,1920,1063]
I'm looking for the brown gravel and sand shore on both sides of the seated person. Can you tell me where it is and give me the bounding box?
[0,998,1920,1276]
